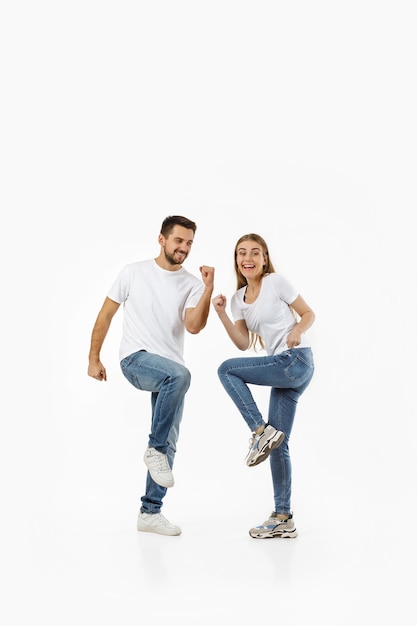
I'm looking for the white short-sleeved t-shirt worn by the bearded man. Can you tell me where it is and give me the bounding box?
[107,259,204,364]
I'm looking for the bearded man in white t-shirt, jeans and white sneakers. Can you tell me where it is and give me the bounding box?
[88,215,214,535]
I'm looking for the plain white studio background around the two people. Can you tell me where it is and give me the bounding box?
[0,0,417,626]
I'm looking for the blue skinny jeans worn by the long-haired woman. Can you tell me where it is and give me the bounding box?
[217,348,314,514]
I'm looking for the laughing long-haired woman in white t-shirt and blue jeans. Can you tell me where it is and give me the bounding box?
[212,233,315,539]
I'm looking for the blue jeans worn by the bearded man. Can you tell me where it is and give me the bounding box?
[120,350,191,513]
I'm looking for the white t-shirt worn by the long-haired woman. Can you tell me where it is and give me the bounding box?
[230,272,310,356]
